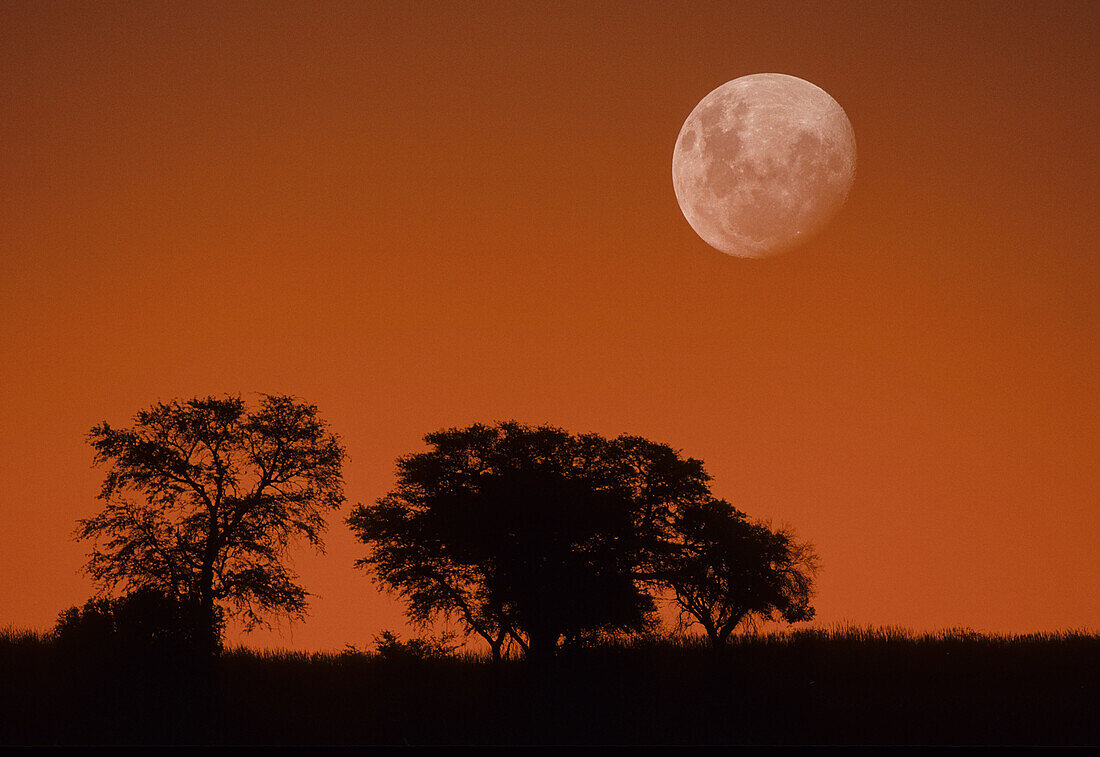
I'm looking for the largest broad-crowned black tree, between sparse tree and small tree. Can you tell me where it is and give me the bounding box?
[348,423,708,659]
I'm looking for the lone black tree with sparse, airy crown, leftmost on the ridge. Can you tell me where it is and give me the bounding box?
[76,395,345,652]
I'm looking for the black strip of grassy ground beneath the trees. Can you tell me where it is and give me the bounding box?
[0,630,1100,745]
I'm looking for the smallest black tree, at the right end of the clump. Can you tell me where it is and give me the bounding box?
[663,500,817,646]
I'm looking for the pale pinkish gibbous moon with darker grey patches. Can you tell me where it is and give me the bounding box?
[672,74,856,257]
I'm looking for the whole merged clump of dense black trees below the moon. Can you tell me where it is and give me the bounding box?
[348,421,816,659]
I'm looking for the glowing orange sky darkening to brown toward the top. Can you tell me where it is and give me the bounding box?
[0,0,1100,649]
